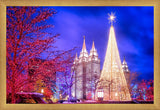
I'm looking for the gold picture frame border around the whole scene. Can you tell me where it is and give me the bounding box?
[0,0,160,110]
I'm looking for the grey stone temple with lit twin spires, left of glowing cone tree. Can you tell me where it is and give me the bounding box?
[72,37,100,99]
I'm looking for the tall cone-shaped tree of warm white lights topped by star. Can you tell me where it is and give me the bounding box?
[96,14,131,101]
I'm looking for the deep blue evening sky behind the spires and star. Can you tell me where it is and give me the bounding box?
[45,6,154,80]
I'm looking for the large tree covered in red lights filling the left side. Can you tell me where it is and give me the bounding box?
[6,7,74,103]
